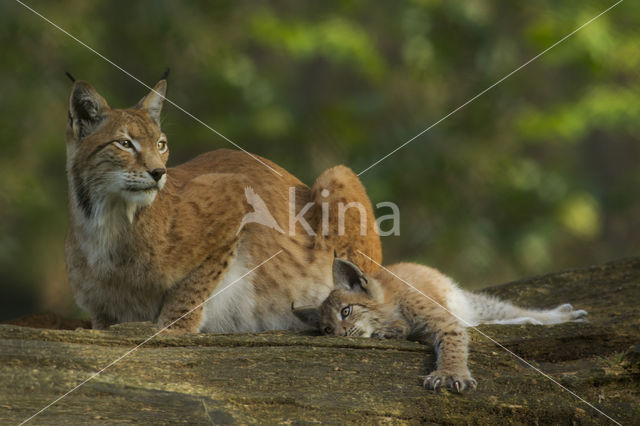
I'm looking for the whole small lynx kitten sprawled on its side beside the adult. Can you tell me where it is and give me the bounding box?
[293,259,587,392]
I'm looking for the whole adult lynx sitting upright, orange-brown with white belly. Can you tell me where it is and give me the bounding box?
[66,75,382,332]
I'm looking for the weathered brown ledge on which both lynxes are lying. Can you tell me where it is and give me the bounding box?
[0,258,640,424]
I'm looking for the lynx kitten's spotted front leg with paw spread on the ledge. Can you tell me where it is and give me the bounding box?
[424,318,477,392]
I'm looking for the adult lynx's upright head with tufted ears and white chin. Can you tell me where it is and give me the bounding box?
[67,78,169,221]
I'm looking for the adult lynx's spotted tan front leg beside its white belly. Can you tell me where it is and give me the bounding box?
[157,252,233,334]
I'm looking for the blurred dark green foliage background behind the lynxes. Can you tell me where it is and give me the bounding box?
[0,0,640,319]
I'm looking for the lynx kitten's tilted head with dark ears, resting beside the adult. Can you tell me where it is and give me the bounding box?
[292,258,386,337]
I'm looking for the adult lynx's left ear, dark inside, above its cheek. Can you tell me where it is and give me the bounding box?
[69,81,109,139]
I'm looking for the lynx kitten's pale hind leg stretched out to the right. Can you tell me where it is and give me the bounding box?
[464,291,587,325]
